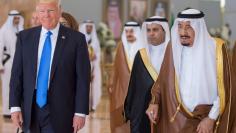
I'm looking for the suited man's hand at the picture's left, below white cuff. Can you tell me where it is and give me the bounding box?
[11,111,23,129]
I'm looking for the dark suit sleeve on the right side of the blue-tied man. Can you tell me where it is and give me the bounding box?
[75,35,91,115]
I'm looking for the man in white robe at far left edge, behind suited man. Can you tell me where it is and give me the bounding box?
[0,10,24,116]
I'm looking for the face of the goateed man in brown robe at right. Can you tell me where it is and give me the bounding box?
[178,21,195,47]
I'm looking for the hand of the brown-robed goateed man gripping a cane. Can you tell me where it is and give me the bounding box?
[146,104,158,124]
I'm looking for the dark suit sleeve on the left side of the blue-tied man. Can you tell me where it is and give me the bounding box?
[9,31,23,107]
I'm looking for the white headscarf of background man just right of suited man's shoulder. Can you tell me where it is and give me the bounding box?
[79,20,100,57]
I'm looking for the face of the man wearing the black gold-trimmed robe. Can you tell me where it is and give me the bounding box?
[147,23,165,46]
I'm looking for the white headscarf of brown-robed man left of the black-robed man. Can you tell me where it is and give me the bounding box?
[121,22,143,62]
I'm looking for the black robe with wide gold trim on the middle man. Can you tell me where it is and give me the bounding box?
[125,49,157,133]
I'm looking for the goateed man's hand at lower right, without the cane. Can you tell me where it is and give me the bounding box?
[197,117,215,133]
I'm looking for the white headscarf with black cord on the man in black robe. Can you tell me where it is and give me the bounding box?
[142,16,170,73]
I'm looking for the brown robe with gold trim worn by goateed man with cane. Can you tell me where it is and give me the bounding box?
[152,40,231,133]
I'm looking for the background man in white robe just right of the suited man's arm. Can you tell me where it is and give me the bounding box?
[80,20,102,111]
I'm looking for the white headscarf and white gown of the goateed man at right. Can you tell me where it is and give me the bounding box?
[171,9,217,112]
